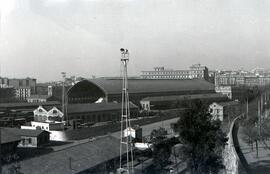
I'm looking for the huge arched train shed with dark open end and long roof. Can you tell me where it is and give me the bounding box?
[67,78,215,104]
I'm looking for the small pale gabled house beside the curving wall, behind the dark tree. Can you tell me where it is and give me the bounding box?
[209,101,241,122]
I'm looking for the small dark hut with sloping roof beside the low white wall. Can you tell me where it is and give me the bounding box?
[3,128,50,147]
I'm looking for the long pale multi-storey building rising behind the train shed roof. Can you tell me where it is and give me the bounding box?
[141,64,209,80]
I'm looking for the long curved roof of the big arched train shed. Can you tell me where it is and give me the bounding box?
[68,78,215,95]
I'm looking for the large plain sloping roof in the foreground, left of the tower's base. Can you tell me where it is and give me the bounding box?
[5,136,125,174]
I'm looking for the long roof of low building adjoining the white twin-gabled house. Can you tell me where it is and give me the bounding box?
[68,102,138,113]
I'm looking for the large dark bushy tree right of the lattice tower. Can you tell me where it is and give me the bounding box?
[174,100,227,174]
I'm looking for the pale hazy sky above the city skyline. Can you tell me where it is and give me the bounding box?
[0,0,270,82]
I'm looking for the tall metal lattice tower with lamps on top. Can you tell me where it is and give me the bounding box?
[118,48,133,174]
